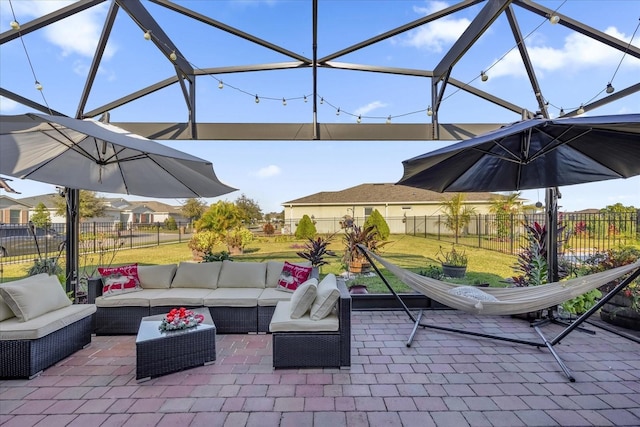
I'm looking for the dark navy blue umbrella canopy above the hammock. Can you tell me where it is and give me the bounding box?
[398,114,640,192]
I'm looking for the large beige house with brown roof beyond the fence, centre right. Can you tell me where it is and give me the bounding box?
[282,183,504,233]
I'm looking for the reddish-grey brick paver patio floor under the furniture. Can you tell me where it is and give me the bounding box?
[0,310,640,427]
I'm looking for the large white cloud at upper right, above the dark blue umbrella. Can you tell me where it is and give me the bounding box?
[490,27,640,77]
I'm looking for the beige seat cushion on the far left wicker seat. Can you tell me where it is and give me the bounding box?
[0,304,96,341]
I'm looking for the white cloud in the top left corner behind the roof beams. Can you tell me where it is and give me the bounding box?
[3,0,117,59]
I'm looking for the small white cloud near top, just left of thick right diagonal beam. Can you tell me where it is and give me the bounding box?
[397,1,471,52]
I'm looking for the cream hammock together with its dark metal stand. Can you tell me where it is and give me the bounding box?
[358,245,640,382]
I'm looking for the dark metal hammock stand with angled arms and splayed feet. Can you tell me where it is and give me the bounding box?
[358,245,640,382]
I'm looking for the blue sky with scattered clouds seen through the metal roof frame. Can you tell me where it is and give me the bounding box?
[0,0,640,213]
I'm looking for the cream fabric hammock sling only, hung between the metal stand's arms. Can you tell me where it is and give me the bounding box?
[367,251,640,315]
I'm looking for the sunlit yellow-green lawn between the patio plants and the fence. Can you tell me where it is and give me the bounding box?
[2,235,516,292]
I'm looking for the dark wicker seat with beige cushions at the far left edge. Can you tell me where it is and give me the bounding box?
[0,273,96,378]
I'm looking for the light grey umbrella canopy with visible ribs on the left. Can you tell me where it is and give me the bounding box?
[0,114,235,198]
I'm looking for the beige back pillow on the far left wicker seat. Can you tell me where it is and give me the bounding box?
[0,273,71,322]
